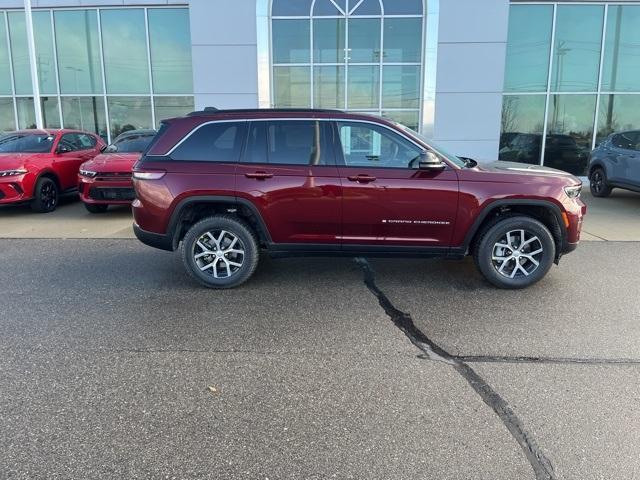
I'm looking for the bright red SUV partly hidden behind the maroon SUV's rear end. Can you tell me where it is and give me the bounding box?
[78,130,156,213]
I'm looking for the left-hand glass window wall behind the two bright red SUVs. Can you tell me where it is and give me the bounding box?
[0,7,194,141]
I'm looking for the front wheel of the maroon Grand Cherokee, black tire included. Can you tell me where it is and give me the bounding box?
[473,215,556,289]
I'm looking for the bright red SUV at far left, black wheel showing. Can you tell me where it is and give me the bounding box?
[0,130,105,212]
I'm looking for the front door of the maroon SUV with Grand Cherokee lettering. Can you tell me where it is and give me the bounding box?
[337,122,458,249]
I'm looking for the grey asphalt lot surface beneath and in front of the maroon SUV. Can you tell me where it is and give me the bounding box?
[0,239,640,479]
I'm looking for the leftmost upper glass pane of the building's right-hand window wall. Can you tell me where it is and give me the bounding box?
[504,5,553,92]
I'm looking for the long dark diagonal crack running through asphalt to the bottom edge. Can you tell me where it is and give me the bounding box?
[355,257,556,480]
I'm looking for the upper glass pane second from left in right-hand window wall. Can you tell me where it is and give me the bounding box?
[551,5,604,92]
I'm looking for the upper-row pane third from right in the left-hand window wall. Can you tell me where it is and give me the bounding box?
[53,10,102,94]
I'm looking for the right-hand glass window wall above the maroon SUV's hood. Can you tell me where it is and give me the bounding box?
[500,2,640,175]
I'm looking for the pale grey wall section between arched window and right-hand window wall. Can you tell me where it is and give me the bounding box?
[427,0,509,161]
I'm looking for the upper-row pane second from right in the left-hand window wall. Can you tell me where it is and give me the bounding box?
[100,8,149,94]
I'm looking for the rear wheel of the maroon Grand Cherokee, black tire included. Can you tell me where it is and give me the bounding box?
[180,215,259,289]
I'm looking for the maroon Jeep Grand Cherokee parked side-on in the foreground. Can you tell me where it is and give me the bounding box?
[133,109,586,288]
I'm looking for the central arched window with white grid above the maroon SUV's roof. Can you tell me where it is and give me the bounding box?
[271,0,424,130]
